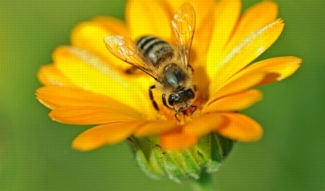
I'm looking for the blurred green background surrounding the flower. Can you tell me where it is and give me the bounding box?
[0,0,325,191]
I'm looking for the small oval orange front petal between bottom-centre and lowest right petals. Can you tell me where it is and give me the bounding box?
[183,113,223,136]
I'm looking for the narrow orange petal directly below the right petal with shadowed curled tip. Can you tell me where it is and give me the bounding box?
[205,73,266,107]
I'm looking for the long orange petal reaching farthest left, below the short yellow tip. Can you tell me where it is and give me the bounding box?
[36,86,140,117]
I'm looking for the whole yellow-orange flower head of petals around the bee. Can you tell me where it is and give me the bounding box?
[37,0,301,151]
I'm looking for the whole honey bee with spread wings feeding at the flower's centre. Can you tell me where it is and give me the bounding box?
[104,3,196,120]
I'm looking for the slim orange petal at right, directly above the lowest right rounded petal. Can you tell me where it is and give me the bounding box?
[202,90,262,113]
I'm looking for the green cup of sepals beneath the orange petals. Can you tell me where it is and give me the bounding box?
[129,133,234,182]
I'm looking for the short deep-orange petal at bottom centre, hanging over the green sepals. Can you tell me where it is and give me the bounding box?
[160,131,199,151]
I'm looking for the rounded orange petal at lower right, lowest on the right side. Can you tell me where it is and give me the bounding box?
[216,113,263,142]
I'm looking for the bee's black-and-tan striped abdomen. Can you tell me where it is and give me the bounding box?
[136,36,174,66]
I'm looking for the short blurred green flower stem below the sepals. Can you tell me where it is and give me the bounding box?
[191,172,216,191]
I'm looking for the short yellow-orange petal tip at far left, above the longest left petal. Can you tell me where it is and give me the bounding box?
[37,64,73,86]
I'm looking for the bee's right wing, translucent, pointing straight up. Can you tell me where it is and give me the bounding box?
[171,3,195,67]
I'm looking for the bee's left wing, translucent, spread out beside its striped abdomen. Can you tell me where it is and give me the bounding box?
[104,36,158,80]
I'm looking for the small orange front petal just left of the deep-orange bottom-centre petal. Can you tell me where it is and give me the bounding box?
[134,120,177,137]
